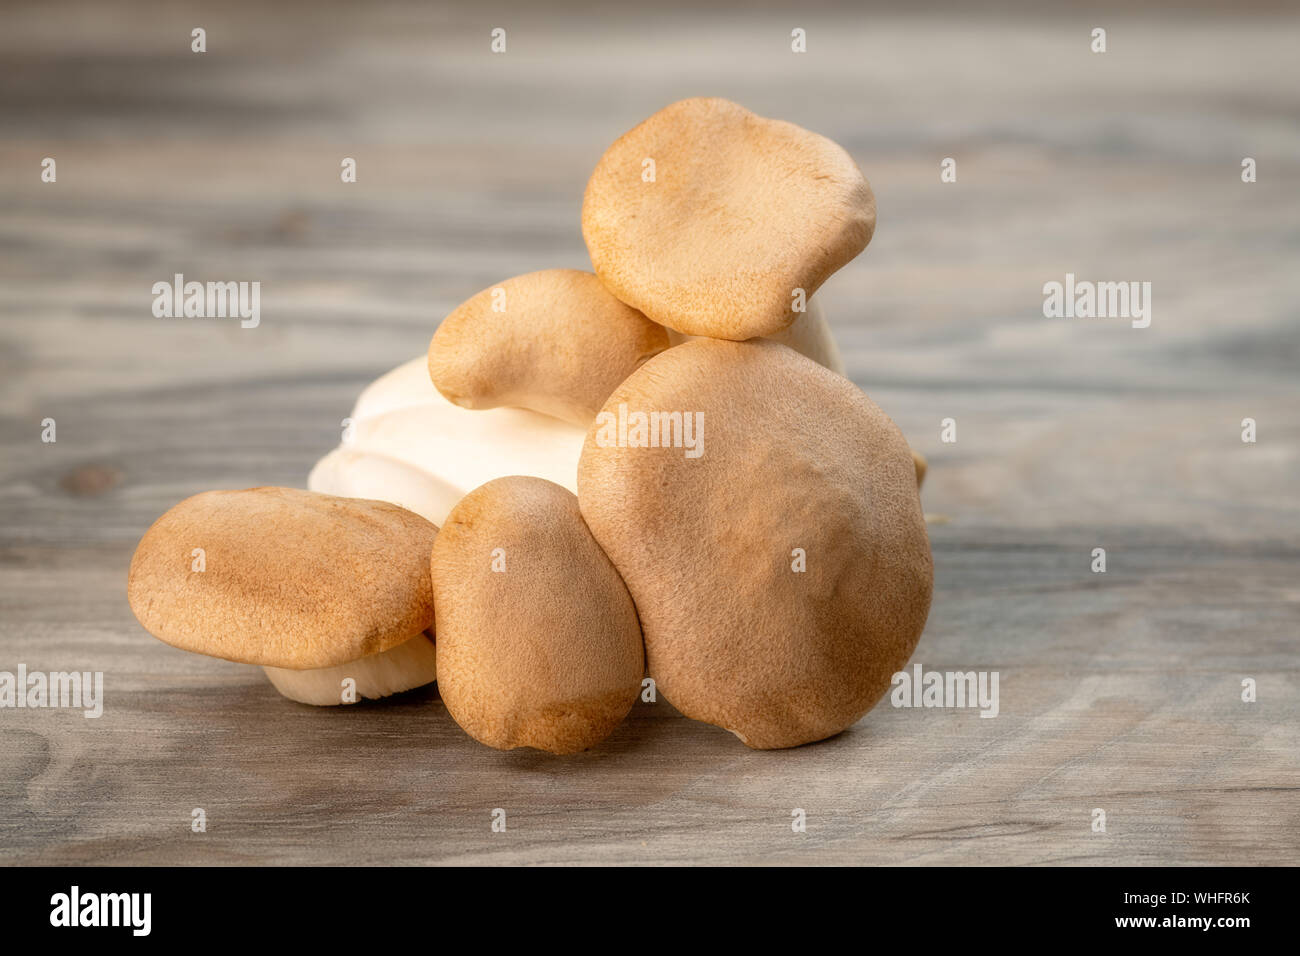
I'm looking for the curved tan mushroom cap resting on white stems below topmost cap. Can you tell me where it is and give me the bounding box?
[429,269,668,428]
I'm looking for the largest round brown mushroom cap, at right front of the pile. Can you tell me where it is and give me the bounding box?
[577,338,933,748]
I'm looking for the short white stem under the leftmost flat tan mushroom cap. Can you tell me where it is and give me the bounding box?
[263,631,437,706]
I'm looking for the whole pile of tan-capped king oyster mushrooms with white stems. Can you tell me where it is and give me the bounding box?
[127,99,933,753]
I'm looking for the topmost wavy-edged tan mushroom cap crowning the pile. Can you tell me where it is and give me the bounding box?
[582,98,876,339]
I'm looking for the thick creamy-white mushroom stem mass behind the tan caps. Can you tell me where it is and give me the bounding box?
[307,355,585,524]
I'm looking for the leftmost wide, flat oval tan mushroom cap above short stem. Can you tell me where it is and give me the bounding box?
[126,488,438,670]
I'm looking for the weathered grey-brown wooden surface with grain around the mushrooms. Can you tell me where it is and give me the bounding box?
[0,1,1300,865]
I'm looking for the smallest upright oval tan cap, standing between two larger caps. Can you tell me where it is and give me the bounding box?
[430,477,645,753]
